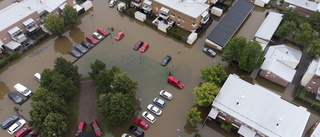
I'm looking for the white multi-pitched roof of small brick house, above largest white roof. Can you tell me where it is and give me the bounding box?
[261,45,302,82]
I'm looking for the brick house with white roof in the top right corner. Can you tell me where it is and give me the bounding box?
[281,0,320,17]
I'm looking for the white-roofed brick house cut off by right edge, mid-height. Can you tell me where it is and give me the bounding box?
[301,60,320,100]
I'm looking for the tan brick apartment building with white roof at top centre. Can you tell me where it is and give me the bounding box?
[142,0,210,32]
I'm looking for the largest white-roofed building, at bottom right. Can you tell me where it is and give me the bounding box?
[208,74,310,137]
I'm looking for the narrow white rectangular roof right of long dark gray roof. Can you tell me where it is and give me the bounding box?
[255,12,283,41]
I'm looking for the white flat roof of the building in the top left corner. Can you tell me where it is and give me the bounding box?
[0,0,66,31]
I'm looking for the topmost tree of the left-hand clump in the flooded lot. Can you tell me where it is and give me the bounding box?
[54,57,81,86]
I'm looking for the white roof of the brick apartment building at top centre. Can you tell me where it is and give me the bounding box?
[155,0,209,18]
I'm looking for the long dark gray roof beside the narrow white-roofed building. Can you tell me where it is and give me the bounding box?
[207,0,254,47]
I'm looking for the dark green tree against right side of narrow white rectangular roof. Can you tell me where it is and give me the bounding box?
[274,21,297,41]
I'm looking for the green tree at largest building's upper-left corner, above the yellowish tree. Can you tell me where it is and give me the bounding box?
[201,62,228,86]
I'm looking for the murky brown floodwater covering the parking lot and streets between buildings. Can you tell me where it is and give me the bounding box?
[0,0,316,137]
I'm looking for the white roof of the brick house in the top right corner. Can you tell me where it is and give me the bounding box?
[284,0,320,11]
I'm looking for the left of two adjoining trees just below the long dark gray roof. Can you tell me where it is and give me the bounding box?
[221,36,247,63]
